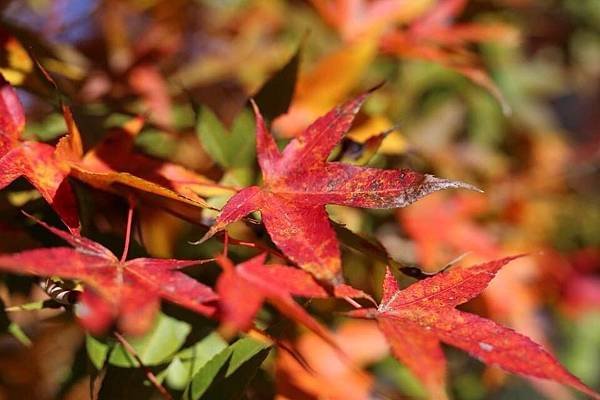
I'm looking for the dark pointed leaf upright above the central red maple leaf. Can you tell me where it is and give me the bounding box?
[254,46,301,120]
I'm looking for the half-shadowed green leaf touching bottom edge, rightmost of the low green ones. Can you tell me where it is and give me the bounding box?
[183,338,270,400]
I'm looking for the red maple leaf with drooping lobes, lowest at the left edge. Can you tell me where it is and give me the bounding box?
[0,216,217,335]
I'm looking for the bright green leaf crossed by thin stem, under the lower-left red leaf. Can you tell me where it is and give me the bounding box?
[108,314,191,367]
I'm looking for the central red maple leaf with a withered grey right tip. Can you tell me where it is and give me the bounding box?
[202,94,476,284]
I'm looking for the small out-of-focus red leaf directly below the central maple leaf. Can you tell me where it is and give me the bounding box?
[217,254,373,343]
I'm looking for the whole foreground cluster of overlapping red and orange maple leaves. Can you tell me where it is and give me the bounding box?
[0,72,600,398]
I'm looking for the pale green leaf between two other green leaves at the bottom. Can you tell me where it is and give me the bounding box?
[165,332,227,390]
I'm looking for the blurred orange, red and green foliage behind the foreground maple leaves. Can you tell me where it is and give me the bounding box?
[0,0,600,400]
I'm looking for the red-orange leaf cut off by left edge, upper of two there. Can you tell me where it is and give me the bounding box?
[0,75,79,233]
